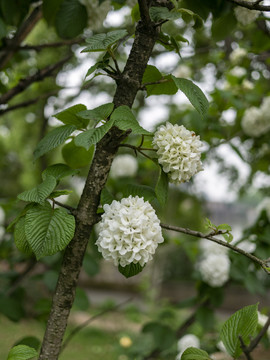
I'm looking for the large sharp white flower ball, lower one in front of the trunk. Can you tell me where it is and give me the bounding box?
[96,196,164,266]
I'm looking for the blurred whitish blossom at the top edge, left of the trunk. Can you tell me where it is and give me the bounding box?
[79,0,112,30]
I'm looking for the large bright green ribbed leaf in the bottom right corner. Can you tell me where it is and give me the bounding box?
[220,304,258,358]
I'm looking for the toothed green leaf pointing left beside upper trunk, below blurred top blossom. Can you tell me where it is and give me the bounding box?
[82,30,128,52]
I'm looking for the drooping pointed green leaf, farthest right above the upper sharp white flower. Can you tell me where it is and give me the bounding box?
[171,75,209,117]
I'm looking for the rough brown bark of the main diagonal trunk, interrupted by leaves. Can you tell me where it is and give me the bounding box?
[39,11,158,360]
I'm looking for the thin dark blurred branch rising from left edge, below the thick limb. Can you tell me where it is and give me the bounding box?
[0,55,73,104]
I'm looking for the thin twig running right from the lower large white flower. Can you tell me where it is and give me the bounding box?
[160,224,270,275]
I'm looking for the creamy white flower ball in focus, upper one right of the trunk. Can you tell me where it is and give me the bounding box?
[153,122,203,184]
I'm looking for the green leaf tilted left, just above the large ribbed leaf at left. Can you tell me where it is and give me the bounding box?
[18,176,56,204]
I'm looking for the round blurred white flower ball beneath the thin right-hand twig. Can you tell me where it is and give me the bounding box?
[197,254,230,287]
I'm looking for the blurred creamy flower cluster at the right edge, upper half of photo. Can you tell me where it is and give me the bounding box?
[241,96,270,137]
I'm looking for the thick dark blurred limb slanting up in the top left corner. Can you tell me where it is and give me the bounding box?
[0,5,42,69]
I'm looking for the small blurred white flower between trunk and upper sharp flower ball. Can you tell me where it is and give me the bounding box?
[110,154,138,179]
